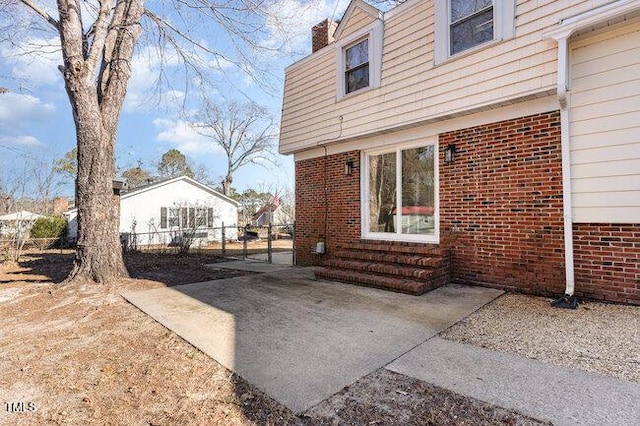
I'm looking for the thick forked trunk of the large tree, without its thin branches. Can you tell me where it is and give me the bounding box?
[58,0,144,283]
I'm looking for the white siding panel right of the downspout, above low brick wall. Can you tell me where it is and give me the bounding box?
[570,20,640,223]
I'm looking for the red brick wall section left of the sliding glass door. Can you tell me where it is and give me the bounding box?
[296,151,360,266]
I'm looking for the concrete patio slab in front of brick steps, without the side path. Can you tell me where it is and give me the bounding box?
[123,268,501,412]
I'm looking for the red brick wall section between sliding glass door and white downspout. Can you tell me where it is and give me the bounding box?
[439,112,564,295]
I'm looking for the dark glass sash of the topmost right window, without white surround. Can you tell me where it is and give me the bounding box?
[449,0,494,55]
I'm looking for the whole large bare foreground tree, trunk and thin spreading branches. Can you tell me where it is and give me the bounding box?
[0,0,288,283]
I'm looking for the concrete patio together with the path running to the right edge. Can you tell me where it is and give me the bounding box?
[123,264,640,425]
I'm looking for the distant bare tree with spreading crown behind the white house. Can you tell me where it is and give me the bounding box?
[192,102,277,196]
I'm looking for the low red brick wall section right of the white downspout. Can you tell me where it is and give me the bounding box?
[573,223,640,305]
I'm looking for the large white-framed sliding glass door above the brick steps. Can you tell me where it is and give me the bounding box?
[362,142,438,242]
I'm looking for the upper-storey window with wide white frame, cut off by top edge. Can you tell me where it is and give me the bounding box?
[434,0,515,64]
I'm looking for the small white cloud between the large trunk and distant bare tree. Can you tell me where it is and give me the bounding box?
[153,118,220,155]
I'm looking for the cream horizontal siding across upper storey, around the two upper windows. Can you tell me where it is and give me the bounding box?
[280,0,593,153]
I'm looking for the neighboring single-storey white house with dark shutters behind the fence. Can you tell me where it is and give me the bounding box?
[66,176,238,245]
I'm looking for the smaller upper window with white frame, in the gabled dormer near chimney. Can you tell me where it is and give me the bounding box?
[335,20,383,101]
